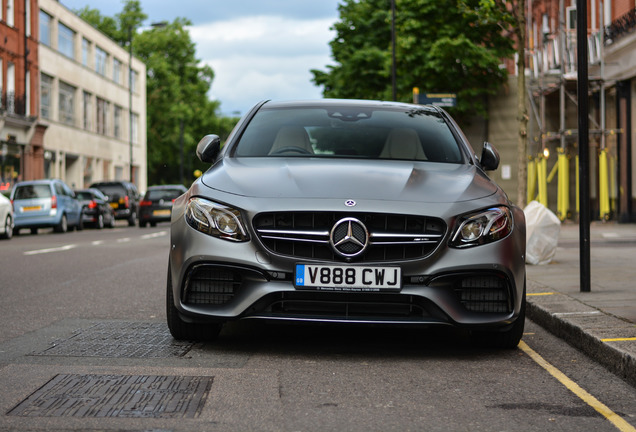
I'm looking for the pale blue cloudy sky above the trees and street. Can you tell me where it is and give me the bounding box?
[60,0,339,115]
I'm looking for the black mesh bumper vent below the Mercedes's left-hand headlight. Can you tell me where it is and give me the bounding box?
[183,265,241,305]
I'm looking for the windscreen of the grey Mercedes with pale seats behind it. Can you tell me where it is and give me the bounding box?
[233,106,463,163]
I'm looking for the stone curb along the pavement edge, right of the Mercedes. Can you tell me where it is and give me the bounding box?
[526,294,636,387]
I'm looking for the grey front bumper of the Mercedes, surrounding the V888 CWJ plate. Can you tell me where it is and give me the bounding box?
[170,208,525,328]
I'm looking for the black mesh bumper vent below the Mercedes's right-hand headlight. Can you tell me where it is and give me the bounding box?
[455,276,512,313]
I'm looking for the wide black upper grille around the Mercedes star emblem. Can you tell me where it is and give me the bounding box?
[253,212,446,262]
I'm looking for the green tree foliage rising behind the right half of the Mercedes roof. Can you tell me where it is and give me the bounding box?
[311,0,514,116]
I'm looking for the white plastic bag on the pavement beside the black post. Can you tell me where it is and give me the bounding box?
[523,201,561,265]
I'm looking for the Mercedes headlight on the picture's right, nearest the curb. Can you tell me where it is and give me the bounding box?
[450,207,512,248]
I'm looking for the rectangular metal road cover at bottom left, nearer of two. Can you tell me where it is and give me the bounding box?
[7,374,214,418]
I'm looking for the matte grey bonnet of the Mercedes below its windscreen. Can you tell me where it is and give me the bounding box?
[201,158,498,203]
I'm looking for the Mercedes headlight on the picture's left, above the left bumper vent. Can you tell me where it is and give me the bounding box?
[185,198,249,242]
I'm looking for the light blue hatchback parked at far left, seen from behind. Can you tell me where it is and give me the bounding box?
[11,179,83,234]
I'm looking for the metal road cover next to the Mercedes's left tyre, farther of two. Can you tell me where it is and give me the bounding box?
[31,321,194,358]
